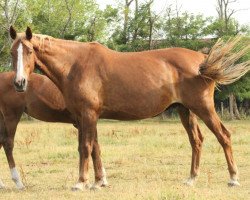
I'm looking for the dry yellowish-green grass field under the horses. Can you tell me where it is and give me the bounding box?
[0,120,250,200]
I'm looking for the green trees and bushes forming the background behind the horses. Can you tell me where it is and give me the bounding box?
[0,0,250,111]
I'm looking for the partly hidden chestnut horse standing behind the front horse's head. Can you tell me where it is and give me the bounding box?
[0,72,74,189]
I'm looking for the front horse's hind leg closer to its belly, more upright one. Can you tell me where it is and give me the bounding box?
[178,105,203,185]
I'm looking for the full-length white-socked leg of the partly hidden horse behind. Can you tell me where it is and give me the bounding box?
[3,114,25,190]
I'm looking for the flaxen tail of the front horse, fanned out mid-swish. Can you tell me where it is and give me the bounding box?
[200,36,250,85]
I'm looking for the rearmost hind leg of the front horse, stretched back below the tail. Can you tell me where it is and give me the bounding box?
[193,106,240,186]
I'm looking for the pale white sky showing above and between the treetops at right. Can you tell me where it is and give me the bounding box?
[97,0,250,25]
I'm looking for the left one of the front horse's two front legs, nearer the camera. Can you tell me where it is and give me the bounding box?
[72,109,102,190]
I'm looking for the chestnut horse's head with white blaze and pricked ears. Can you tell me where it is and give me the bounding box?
[10,26,35,92]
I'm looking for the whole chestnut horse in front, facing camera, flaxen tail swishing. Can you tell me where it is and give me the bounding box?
[10,27,249,190]
